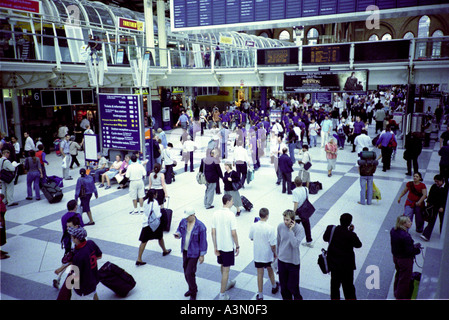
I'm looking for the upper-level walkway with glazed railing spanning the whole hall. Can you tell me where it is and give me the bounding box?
[0,31,449,89]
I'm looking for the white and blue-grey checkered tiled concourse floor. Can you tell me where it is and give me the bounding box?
[0,121,445,300]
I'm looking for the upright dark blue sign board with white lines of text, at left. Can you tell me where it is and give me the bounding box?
[98,94,142,151]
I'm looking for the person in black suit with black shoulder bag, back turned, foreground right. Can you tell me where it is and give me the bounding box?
[323,213,362,300]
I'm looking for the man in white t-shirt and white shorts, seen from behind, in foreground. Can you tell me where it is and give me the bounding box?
[249,208,279,300]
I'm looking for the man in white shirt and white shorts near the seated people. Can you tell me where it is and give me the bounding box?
[126,154,147,214]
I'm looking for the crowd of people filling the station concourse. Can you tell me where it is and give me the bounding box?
[1,91,449,300]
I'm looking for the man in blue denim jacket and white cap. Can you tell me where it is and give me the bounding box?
[174,208,207,300]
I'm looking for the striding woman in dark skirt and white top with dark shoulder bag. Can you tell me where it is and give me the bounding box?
[136,189,171,266]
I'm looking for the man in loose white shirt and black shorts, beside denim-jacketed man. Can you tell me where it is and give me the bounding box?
[212,194,240,300]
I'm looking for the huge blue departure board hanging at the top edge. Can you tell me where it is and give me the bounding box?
[170,0,440,31]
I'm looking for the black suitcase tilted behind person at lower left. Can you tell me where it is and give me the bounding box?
[98,261,136,298]
